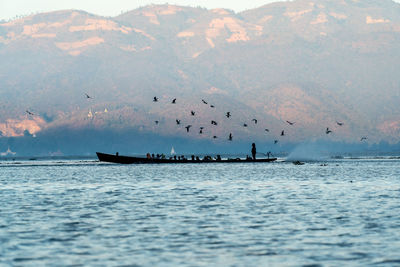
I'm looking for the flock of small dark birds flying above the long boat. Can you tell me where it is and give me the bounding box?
[26,93,368,144]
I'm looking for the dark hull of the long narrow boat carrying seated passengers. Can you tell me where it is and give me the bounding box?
[96,152,276,164]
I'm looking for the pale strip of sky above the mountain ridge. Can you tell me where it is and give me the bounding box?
[0,0,285,19]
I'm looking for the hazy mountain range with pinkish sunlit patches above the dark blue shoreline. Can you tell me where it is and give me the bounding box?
[0,0,400,155]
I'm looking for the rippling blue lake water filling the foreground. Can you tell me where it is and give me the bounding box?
[0,159,400,266]
